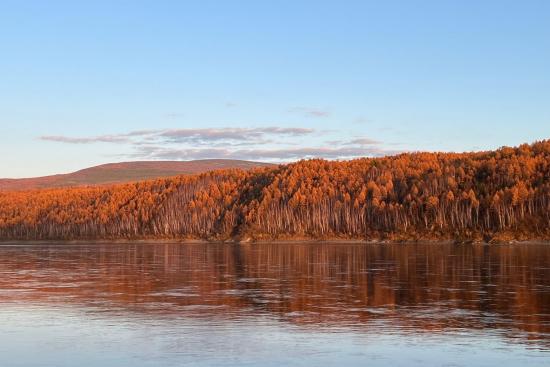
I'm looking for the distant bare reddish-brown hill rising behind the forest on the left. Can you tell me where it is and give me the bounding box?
[0,159,270,191]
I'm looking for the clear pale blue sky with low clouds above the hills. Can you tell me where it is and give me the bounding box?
[0,0,550,177]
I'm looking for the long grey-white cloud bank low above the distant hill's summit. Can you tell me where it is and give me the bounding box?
[39,126,398,162]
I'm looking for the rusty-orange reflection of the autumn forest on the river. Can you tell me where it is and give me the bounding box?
[0,244,550,366]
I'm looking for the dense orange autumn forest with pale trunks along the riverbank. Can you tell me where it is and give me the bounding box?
[0,140,550,240]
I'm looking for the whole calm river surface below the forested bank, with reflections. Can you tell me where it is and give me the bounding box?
[0,244,550,367]
